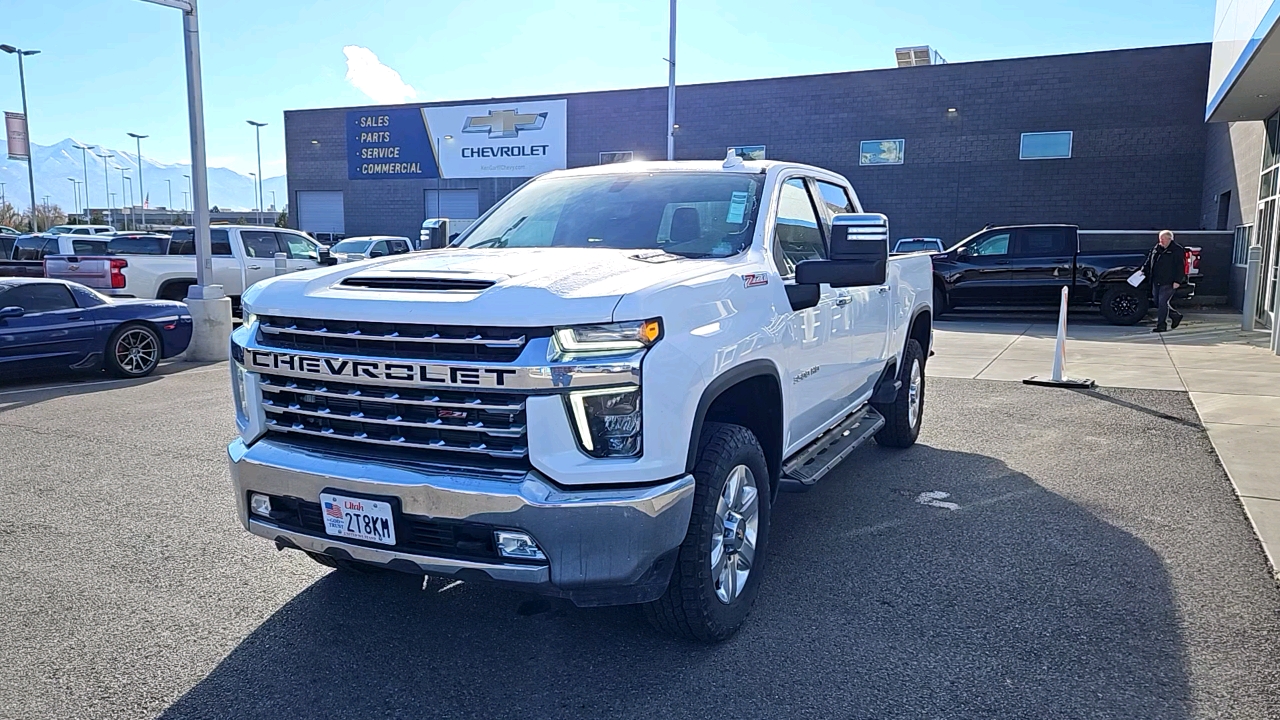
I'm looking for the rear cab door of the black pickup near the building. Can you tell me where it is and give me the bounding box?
[1006,227,1075,305]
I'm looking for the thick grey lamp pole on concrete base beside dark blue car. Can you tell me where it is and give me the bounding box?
[143,0,232,361]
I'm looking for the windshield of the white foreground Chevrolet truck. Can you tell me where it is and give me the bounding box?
[456,172,764,258]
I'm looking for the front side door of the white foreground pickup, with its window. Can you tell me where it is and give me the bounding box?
[773,177,856,445]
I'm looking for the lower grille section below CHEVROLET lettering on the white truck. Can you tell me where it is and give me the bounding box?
[259,374,529,461]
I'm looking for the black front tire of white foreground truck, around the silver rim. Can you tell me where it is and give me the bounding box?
[644,423,771,643]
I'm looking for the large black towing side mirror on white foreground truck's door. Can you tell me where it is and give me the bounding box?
[796,213,888,287]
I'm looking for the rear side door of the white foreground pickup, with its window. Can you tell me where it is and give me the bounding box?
[813,181,890,401]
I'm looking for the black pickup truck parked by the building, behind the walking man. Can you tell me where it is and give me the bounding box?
[933,224,1204,325]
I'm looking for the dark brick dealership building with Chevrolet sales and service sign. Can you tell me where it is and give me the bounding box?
[284,41,1254,304]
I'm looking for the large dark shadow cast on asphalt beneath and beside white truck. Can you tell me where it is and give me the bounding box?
[163,445,1190,720]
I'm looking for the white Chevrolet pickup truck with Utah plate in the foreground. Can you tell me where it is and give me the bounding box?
[228,158,933,642]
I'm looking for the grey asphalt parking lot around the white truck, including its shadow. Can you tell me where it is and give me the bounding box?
[0,364,1280,720]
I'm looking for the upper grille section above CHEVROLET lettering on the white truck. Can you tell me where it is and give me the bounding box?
[257,315,550,363]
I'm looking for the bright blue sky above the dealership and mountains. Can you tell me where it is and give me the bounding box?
[0,0,1213,177]
